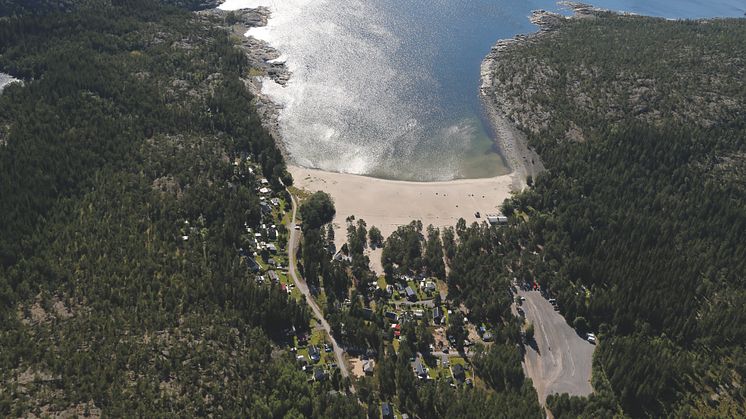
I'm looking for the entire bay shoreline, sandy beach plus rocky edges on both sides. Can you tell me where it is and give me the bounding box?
[213,2,568,274]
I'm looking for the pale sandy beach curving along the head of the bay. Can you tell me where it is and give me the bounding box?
[288,166,515,273]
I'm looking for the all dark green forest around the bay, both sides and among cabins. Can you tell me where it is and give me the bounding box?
[0,0,746,418]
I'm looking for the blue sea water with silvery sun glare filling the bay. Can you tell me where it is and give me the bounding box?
[221,0,746,181]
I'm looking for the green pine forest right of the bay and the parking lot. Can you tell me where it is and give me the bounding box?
[486,13,746,417]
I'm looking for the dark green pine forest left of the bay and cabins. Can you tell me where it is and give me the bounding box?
[0,1,360,417]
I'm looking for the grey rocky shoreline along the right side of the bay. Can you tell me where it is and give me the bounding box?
[479,2,597,185]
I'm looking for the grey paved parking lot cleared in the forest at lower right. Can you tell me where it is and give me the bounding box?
[518,291,596,405]
